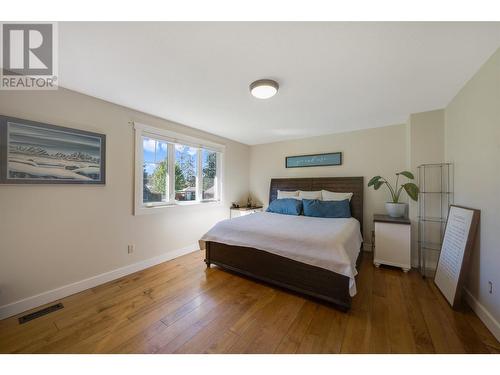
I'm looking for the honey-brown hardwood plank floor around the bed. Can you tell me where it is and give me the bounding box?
[0,252,500,353]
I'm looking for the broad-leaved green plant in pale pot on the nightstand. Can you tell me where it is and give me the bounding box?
[368,171,419,217]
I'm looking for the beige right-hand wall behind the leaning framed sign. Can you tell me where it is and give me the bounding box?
[445,50,500,330]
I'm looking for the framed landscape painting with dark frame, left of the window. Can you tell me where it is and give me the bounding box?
[0,116,106,185]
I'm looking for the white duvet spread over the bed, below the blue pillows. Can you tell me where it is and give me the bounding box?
[201,212,363,296]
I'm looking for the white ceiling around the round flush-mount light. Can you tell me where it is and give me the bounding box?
[59,22,500,144]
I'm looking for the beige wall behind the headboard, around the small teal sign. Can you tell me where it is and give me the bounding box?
[250,125,406,246]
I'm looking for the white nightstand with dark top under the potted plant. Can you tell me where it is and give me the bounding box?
[373,214,411,272]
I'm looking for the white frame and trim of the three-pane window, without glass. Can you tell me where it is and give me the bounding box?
[134,122,226,215]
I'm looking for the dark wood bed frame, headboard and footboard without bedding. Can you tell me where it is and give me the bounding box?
[205,177,364,311]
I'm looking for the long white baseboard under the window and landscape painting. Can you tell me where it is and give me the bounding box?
[0,243,199,319]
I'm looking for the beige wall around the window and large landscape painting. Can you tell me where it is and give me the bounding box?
[0,89,249,306]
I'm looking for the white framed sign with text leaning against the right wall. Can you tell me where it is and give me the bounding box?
[434,205,480,308]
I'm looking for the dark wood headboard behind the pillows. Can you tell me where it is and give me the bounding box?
[269,177,364,230]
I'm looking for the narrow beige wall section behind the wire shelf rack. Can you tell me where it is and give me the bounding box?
[406,109,444,267]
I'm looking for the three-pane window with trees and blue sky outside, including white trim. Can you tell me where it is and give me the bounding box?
[135,124,224,214]
